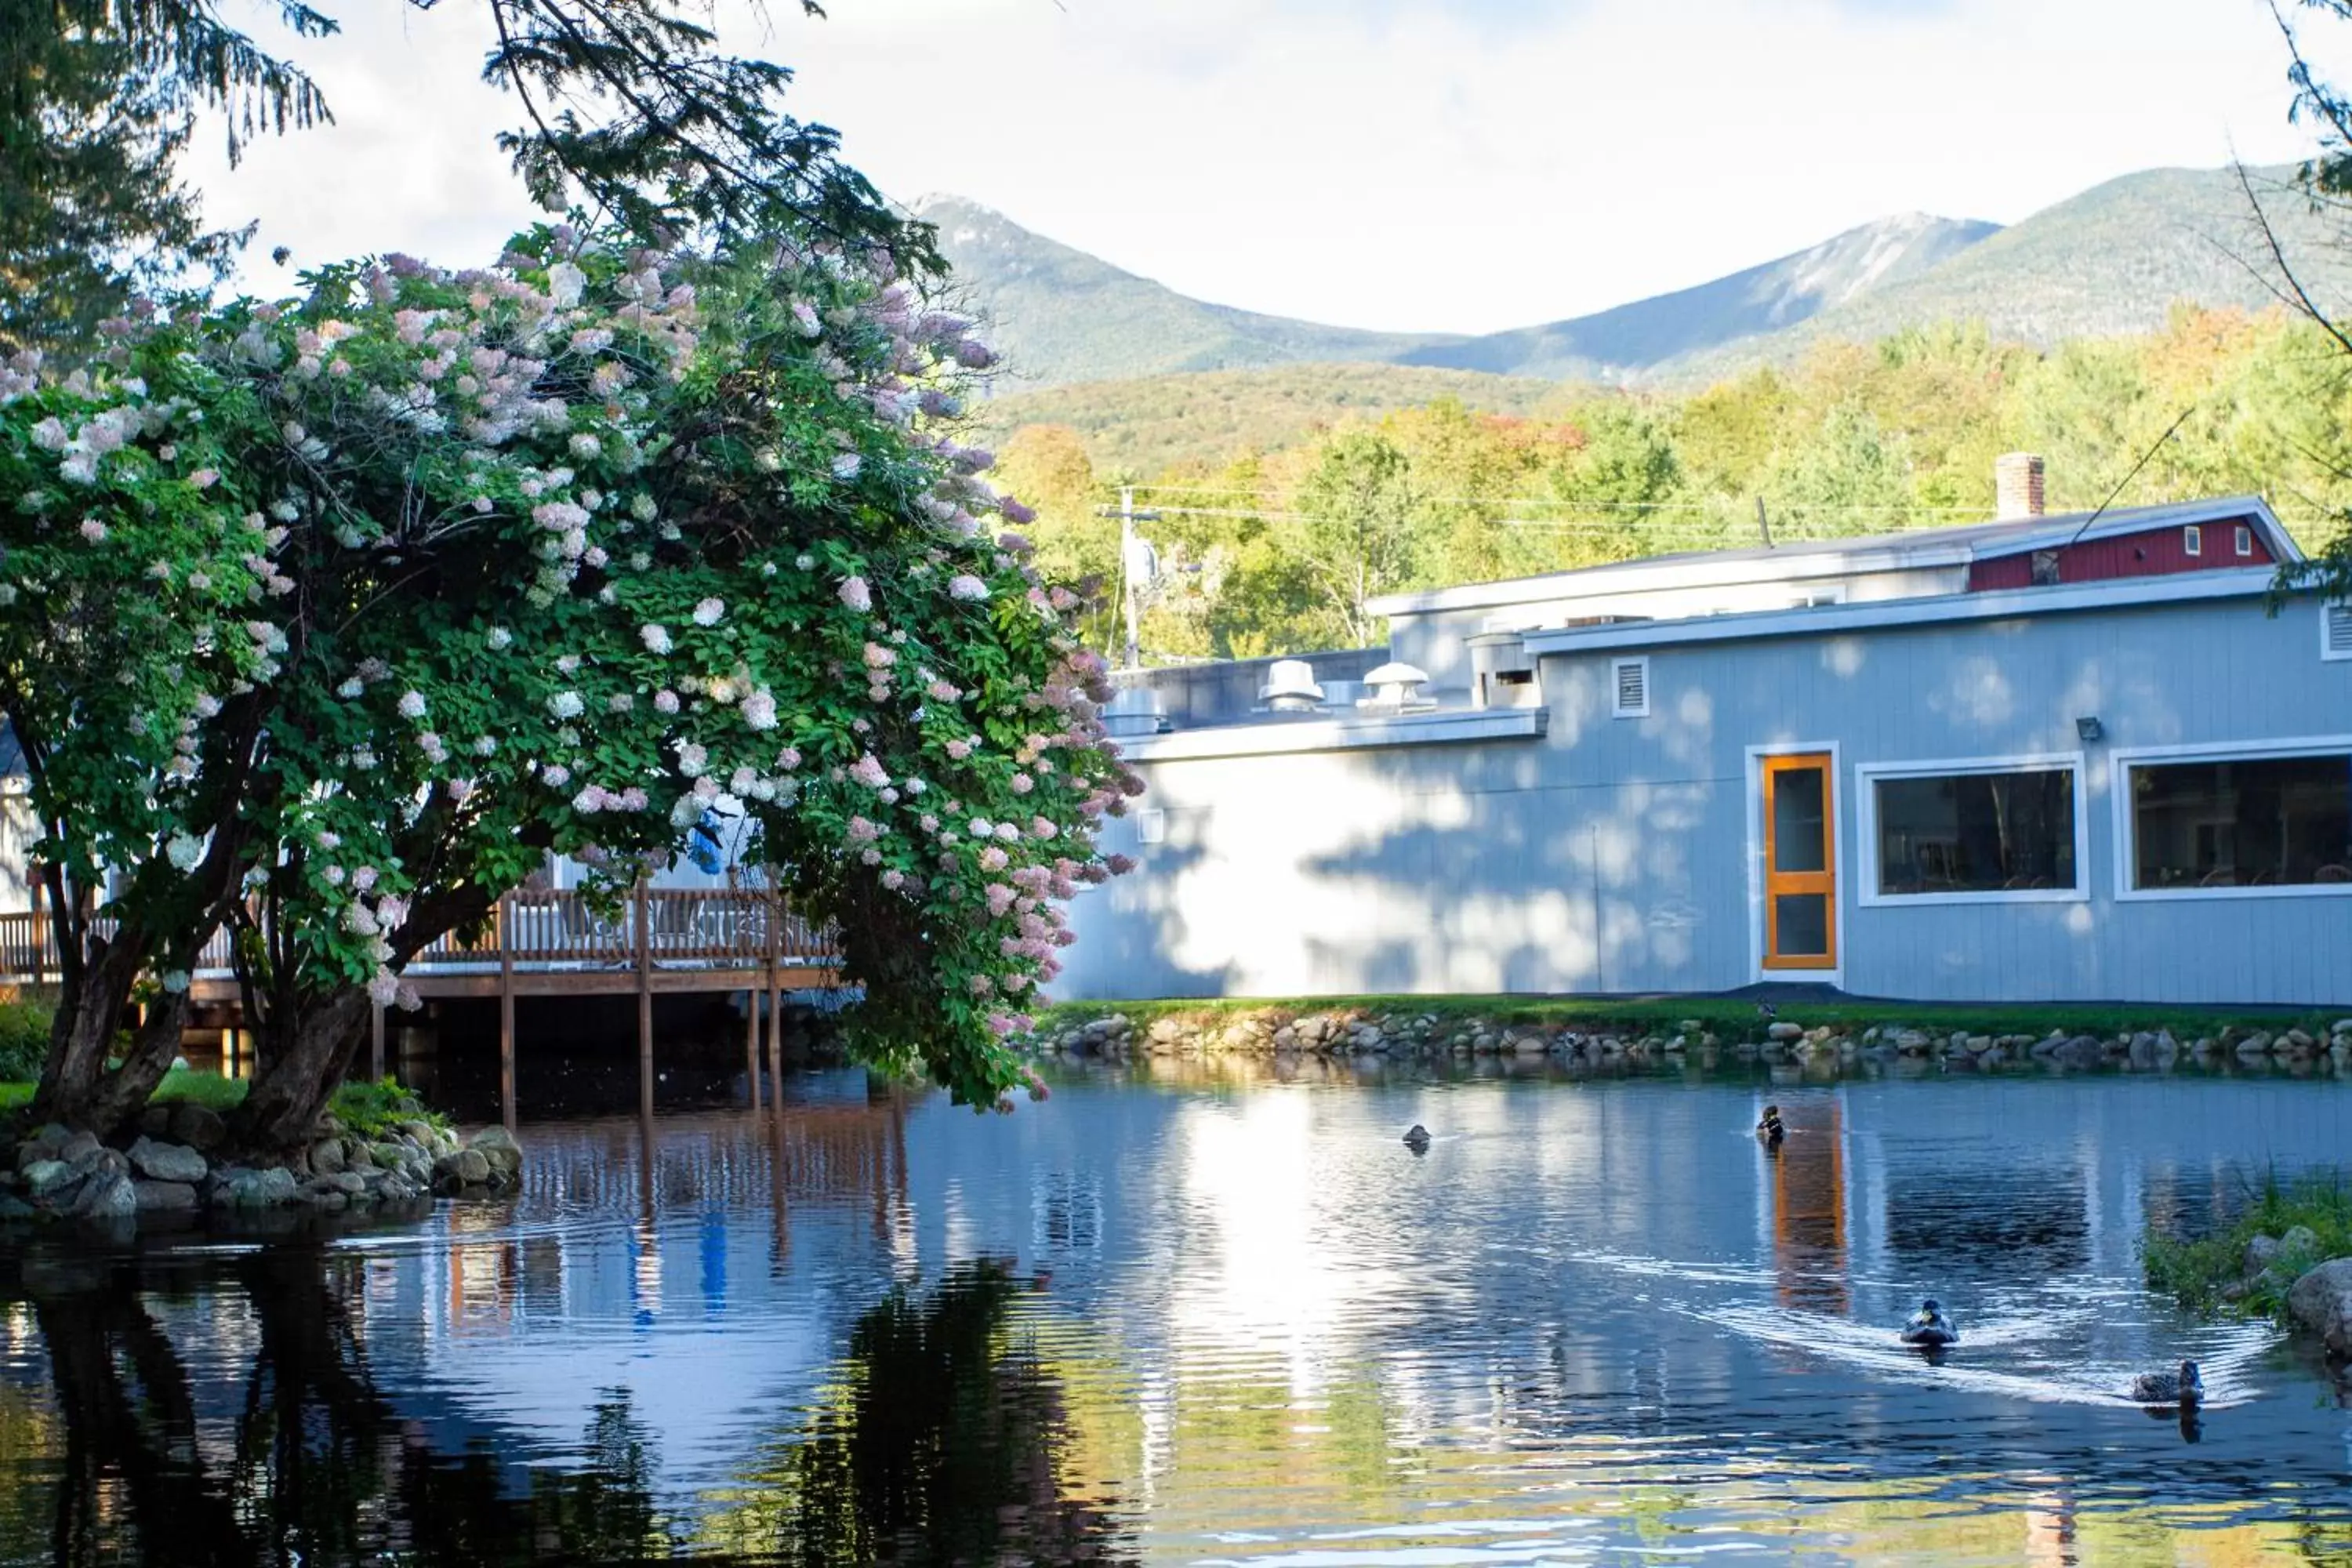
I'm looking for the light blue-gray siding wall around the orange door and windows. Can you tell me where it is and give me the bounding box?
[1054,587,2352,1004]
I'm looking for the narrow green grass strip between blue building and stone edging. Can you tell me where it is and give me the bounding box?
[1037,996,2352,1044]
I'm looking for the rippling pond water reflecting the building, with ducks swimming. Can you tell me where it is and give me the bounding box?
[0,1074,2352,1568]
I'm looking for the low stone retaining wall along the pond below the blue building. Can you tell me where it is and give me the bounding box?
[1028,1008,2352,1072]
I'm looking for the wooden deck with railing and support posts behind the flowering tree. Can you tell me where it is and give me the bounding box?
[0,886,840,1126]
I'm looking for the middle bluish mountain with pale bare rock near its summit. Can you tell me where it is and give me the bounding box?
[1402,212,1999,381]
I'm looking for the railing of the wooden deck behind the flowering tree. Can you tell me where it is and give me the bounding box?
[0,888,840,985]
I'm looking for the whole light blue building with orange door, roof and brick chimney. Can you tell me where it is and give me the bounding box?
[1054,461,2352,1006]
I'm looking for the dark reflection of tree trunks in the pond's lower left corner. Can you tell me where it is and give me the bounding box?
[0,1248,673,1568]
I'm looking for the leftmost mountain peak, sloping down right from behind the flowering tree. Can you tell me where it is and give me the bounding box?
[913,195,1454,388]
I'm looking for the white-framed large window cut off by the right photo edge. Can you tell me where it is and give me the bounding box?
[2124,748,2352,893]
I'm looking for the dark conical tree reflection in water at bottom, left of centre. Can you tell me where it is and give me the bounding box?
[713,1262,1129,1563]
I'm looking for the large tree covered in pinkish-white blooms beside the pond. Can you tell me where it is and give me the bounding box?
[0,230,1141,1145]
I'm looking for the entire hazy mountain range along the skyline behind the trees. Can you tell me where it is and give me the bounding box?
[915,169,2352,397]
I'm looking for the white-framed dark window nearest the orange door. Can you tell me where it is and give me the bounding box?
[1860,757,2084,902]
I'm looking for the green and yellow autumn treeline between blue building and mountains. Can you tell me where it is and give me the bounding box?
[997,308,2352,659]
